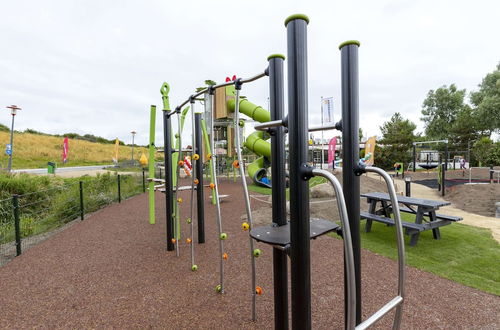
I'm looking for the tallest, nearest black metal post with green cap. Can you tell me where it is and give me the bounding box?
[285,15,308,329]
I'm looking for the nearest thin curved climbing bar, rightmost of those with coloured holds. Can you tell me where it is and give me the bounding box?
[234,89,257,321]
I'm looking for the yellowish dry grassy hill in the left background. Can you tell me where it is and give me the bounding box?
[0,130,148,169]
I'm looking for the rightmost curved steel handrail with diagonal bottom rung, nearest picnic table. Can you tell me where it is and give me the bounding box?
[356,167,405,329]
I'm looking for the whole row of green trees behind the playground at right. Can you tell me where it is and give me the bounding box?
[375,63,500,168]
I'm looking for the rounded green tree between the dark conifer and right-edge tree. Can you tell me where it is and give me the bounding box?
[421,84,467,139]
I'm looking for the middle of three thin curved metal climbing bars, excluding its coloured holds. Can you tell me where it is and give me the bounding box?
[209,94,224,293]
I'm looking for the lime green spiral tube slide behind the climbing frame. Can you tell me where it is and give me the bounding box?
[227,99,271,188]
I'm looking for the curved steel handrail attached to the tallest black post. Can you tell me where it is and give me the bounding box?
[312,169,356,329]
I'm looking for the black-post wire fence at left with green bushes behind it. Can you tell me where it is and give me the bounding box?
[0,171,147,266]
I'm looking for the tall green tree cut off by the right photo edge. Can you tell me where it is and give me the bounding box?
[470,63,500,136]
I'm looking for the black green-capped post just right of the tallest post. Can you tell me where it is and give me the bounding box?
[339,41,361,324]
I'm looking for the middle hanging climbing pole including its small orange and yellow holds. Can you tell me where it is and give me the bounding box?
[208,87,227,293]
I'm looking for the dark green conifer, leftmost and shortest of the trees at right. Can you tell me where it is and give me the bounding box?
[375,112,417,168]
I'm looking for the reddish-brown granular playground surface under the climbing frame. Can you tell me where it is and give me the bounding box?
[0,182,500,329]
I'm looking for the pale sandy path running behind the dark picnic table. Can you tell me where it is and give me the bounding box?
[388,178,500,243]
